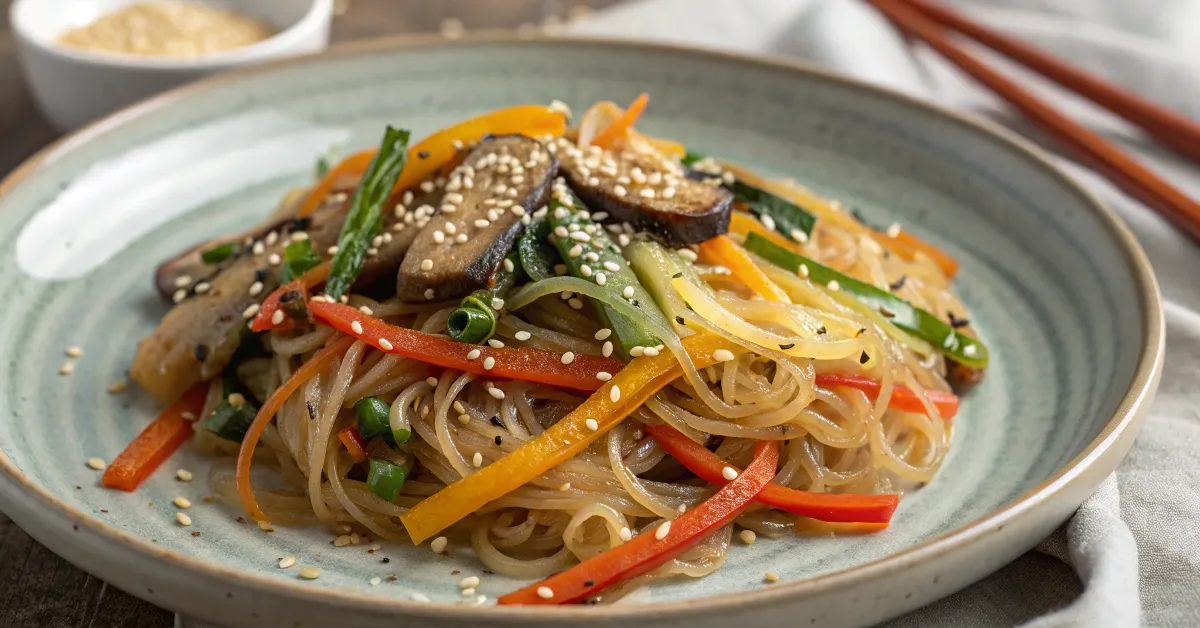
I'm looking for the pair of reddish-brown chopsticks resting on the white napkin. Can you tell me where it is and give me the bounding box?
[865,0,1200,243]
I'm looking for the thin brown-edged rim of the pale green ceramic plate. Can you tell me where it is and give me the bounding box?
[0,30,1165,623]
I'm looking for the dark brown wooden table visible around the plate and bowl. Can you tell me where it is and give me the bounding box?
[0,0,620,628]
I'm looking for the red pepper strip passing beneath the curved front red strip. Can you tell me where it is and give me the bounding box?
[646,425,900,524]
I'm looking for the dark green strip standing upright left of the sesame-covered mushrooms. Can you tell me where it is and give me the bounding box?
[325,126,409,299]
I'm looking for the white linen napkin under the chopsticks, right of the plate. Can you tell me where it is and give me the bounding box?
[571,0,1200,628]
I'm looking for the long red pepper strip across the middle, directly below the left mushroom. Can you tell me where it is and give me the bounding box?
[308,300,622,390]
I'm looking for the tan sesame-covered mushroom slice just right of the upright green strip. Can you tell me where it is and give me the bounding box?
[396,136,558,301]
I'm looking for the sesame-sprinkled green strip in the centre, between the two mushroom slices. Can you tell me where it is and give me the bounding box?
[550,192,671,360]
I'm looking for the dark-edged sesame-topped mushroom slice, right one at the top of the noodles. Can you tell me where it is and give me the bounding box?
[557,138,733,246]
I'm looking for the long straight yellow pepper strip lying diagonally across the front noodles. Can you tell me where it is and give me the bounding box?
[400,334,746,543]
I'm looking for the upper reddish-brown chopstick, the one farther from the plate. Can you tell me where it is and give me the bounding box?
[905,0,1200,163]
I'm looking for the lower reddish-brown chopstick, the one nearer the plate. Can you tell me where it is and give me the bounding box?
[865,0,1200,243]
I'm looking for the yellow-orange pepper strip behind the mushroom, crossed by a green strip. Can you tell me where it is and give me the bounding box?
[296,104,566,217]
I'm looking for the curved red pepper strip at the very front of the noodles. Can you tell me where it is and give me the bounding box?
[497,441,779,604]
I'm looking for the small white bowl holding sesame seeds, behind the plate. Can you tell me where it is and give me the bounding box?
[8,0,334,131]
